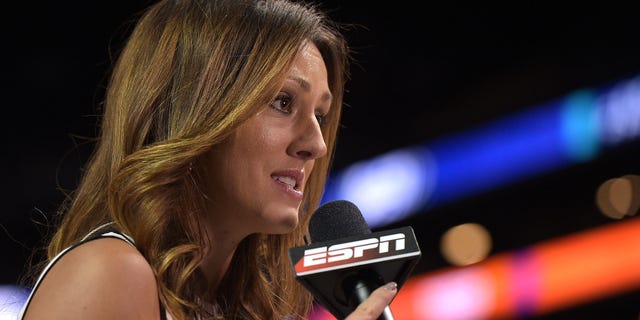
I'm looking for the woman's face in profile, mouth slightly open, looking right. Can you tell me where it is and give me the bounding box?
[208,44,331,236]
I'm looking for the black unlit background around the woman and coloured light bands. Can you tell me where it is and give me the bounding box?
[0,1,640,319]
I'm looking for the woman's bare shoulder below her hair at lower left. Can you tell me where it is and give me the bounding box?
[25,238,160,319]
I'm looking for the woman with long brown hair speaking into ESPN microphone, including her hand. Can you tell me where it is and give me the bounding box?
[22,0,397,319]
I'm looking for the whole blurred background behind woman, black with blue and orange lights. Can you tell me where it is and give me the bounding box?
[0,0,640,319]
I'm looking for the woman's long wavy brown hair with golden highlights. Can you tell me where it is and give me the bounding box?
[42,0,350,320]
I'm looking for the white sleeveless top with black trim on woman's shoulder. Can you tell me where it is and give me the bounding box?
[18,222,171,320]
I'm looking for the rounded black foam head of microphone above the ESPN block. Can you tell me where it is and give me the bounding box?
[309,200,371,242]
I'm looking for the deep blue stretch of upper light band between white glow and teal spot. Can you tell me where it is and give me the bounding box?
[428,102,568,205]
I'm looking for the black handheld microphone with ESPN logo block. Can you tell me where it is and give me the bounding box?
[289,200,422,320]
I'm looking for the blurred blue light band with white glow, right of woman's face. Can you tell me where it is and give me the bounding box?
[323,76,640,228]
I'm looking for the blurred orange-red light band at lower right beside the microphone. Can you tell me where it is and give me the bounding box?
[310,218,640,320]
